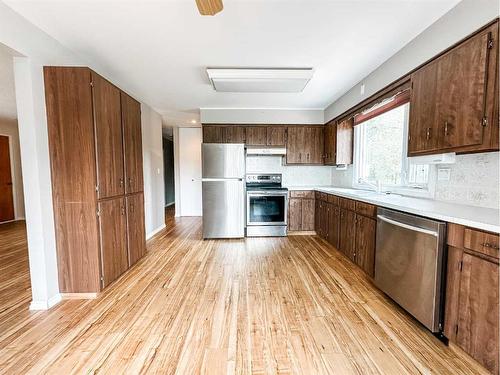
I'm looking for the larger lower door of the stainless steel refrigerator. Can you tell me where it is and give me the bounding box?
[202,178,245,238]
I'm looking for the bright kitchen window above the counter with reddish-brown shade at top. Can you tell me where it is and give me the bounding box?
[353,93,431,197]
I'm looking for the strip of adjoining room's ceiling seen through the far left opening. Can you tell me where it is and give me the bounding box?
[0,44,17,121]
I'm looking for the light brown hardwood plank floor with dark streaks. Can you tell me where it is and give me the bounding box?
[0,216,486,374]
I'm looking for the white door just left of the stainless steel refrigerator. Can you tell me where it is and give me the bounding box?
[179,128,202,216]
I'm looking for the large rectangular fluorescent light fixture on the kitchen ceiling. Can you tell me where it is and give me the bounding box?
[207,68,313,92]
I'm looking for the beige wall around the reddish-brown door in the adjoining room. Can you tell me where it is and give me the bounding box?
[0,119,24,220]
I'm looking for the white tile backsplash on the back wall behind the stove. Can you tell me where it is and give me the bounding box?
[246,156,334,186]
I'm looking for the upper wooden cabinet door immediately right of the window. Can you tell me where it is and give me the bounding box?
[408,62,438,155]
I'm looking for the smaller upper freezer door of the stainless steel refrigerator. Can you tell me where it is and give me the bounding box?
[201,143,245,178]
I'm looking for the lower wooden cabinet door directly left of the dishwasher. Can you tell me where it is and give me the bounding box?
[355,215,377,277]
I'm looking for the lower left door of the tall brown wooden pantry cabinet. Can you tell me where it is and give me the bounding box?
[99,198,128,287]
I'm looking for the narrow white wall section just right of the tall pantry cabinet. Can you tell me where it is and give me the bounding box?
[141,104,165,238]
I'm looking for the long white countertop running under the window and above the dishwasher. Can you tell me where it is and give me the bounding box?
[286,186,500,233]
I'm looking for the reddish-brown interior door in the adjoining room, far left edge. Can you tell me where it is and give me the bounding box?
[0,135,15,222]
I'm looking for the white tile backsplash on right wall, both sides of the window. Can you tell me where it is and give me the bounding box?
[332,152,500,209]
